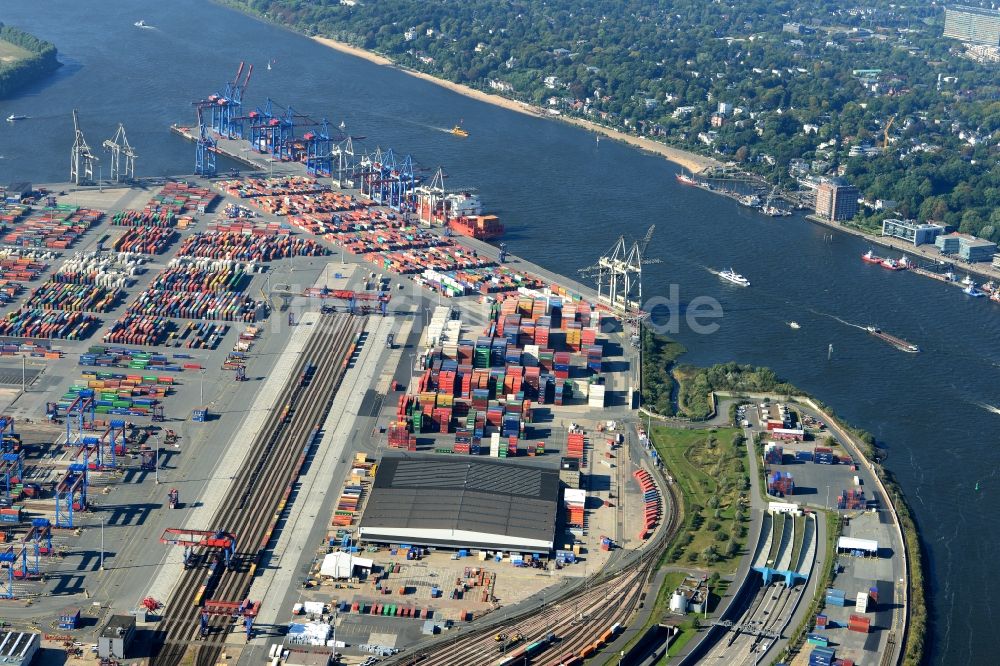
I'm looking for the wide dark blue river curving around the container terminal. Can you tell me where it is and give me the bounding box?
[0,0,1000,663]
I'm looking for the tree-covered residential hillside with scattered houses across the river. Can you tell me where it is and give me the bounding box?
[225,0,1000,240]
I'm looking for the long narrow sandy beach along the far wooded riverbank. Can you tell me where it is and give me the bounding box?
[313,37,722,173]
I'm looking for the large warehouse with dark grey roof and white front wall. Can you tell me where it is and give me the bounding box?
[361,454,559,552]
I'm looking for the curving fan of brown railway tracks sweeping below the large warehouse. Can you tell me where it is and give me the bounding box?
[389,456,680,666]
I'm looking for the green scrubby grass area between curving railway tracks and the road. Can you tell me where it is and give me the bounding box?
[652,426,749,574]
